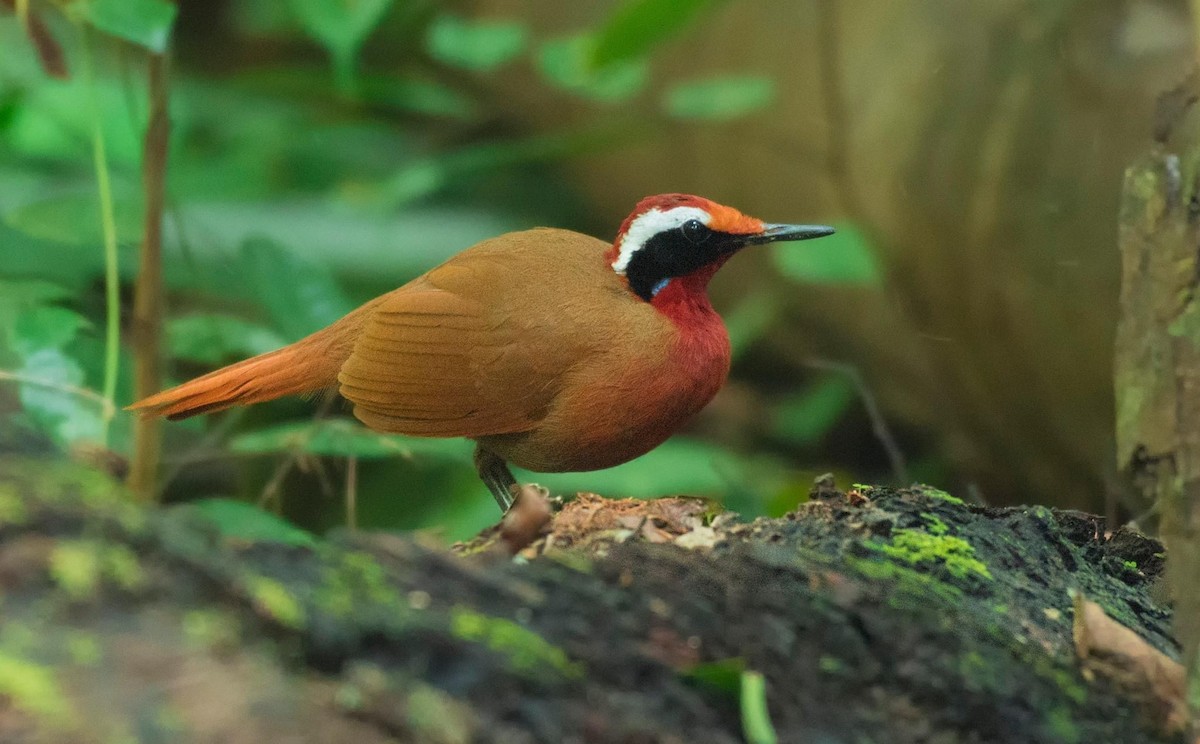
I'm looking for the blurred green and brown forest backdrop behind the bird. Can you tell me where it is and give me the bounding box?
[0,0,1194,539]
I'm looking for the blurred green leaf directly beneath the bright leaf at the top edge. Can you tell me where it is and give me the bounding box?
[538,34,647,103]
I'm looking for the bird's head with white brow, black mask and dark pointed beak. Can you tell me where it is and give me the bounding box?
[608,193,833,304]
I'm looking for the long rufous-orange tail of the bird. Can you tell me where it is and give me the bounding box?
[127,302,374,420]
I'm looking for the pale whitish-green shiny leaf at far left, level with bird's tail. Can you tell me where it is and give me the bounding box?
[18,348,103,448]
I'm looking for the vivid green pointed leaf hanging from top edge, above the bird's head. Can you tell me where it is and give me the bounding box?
[590,0,724,67]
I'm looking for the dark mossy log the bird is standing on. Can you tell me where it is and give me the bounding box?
[0,460,1182,744]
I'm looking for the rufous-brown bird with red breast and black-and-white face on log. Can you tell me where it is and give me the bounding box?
[128,193,834,510]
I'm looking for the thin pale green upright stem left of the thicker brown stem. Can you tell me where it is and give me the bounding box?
[83,28,121,446]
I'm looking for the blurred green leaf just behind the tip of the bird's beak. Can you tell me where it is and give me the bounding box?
[770,223,882,284]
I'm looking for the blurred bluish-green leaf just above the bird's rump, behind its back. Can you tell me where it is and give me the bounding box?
[241,238,354,341]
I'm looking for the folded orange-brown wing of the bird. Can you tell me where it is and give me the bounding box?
[338,249,572,437]
